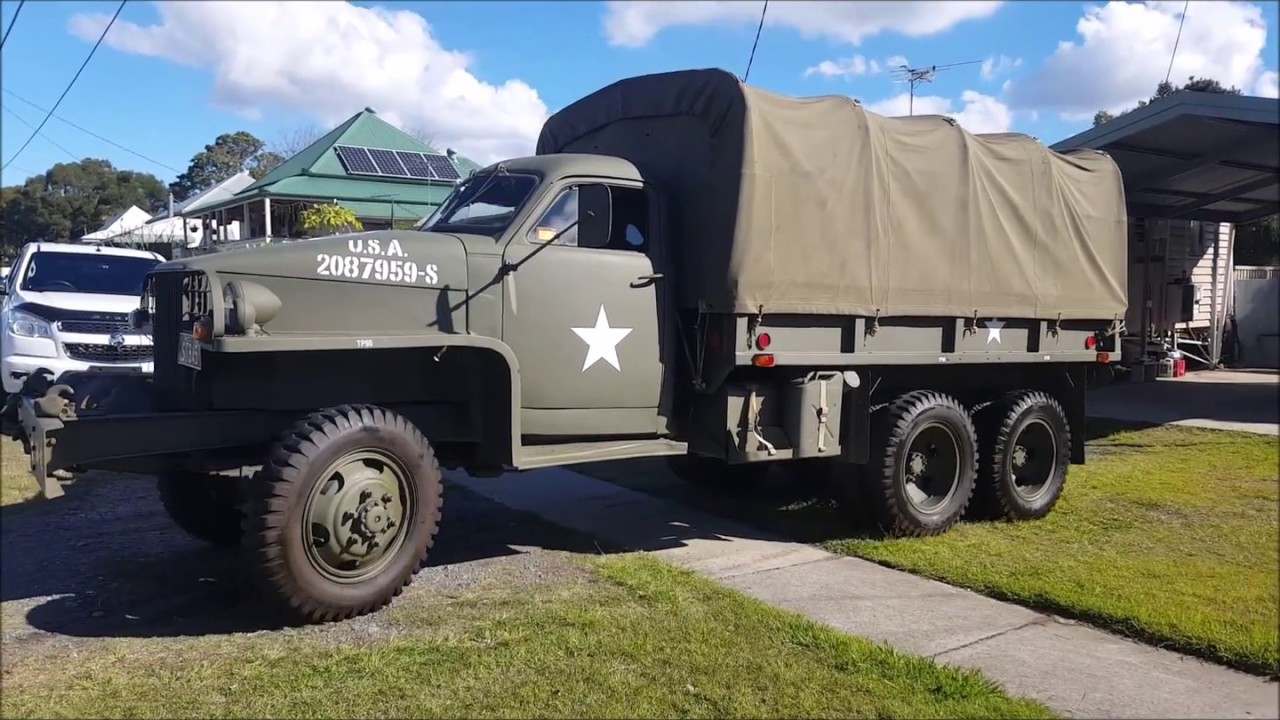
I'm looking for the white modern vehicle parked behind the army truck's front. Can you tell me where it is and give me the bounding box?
[0,242,164,393]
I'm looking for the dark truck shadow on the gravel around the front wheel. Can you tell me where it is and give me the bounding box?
[0,474,640,638]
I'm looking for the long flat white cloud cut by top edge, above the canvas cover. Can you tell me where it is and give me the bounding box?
[604,0,1002,47]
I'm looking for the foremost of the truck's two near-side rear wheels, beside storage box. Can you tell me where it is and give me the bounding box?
[867,391,978,537]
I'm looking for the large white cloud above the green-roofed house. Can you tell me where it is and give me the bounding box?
[70,0,548,161]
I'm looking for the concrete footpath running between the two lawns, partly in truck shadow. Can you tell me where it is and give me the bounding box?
[449,469,1280,719]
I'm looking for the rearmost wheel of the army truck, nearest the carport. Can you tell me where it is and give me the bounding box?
[977,391,1071,520]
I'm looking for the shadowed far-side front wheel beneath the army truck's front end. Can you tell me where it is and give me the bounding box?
[156,473,242,547]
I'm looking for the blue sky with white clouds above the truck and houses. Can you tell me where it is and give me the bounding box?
[0,0,1277,184]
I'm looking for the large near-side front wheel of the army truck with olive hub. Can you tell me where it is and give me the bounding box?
[244,405,443,623]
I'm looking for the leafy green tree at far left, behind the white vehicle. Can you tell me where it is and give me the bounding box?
[0,158,168,251]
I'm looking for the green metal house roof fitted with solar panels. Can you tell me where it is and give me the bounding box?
[192,108,479,219]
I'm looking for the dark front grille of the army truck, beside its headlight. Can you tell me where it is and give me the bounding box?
[142,270,212,404]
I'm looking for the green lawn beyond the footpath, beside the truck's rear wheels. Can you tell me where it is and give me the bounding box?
[580,421,1280,674]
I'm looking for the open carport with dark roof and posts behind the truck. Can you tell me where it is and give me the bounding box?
[1052,92,1280,365]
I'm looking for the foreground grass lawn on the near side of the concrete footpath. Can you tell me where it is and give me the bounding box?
[0,556,1051,717]
